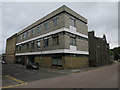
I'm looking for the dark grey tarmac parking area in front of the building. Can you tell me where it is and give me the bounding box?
[2,64,68,86]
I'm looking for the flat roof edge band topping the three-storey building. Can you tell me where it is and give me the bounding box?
[17,5,87,35]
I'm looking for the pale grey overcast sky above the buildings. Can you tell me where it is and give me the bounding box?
[0,2,118,53]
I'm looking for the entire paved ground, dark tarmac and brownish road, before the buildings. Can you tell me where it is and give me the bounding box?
[2,62,118,88]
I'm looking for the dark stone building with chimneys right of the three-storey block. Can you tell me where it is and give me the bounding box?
[88,31,110,66]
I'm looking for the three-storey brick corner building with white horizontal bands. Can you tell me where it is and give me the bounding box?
[6,5,89,69]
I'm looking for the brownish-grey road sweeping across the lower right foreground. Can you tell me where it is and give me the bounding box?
[17,63,118,88]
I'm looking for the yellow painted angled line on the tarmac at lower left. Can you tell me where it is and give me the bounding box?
[2,75,27,88]
